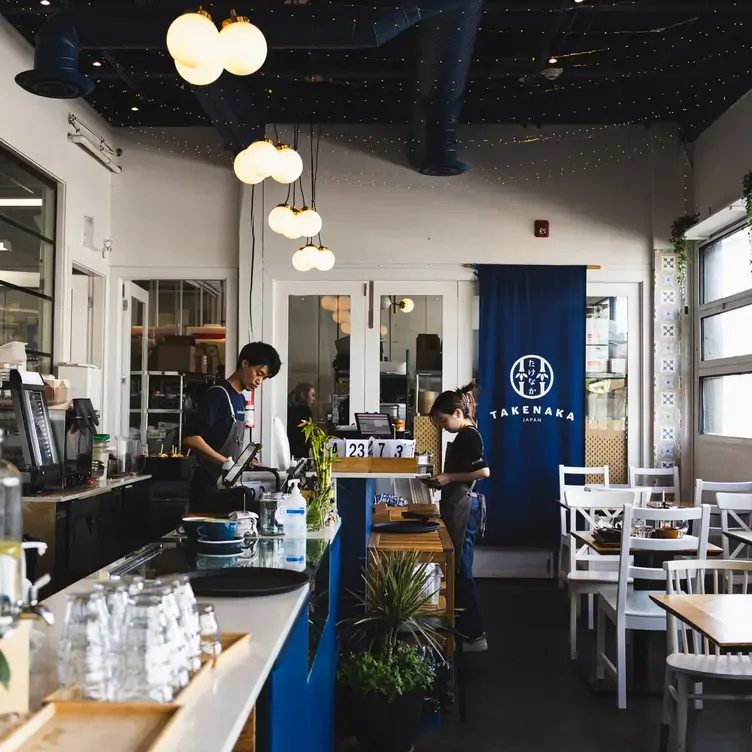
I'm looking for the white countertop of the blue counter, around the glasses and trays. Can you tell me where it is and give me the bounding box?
[31,523,339,752]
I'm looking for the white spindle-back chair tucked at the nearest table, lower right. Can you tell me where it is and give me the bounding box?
[660,561,752,752]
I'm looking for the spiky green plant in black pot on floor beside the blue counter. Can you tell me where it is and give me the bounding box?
[337,551,439,752]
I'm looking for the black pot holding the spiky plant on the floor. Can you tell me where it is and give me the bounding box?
[350,691,423,752]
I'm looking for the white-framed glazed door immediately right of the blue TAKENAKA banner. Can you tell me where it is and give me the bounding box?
[585,282,652,483]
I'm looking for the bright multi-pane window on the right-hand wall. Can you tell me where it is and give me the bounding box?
[697,227,752,439]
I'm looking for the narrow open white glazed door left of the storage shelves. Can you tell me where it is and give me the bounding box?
[120,282,149,444]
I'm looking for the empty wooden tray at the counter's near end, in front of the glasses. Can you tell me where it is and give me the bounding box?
[0,702,181,752]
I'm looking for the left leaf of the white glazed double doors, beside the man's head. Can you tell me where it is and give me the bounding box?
[262,280,367,466]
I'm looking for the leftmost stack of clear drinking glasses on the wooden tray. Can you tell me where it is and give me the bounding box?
[58,590,113,700]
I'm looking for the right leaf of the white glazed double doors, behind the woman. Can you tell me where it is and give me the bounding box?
[365,281,458,431]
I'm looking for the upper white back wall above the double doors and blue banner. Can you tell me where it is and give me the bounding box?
[263,126,686,276]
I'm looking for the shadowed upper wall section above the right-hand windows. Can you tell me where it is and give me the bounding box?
[691,92,752,219]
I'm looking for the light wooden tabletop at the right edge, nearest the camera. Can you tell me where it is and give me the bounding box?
[650,595,752,650]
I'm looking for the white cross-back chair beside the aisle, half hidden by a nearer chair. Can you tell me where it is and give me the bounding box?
[566,487,640,660]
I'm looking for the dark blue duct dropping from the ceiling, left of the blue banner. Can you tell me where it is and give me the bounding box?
[408,0,483,176]
